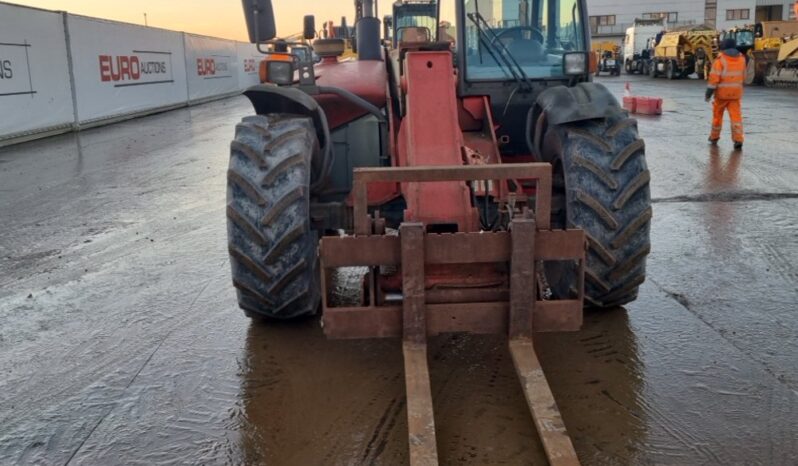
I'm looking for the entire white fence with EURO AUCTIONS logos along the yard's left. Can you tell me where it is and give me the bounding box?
[0,1,255,146]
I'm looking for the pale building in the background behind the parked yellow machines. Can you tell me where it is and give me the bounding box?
[587,0,796,39]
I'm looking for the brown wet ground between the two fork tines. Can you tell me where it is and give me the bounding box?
[429,335,545,465]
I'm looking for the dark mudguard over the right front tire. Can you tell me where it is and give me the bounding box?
[536,82,621,125]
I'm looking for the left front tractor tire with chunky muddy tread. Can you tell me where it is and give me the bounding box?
[227,114,320,320]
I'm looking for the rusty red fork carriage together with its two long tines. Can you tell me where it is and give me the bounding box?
[320,163,586,466]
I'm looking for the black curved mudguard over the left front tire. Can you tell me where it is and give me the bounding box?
[244,84,331,153]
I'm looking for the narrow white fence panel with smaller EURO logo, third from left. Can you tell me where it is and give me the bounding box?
[184,34,239,101]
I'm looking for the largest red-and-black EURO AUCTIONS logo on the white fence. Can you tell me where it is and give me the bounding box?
[99,50,174,87]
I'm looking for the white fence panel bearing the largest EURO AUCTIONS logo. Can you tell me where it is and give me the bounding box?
[68,15,188,125]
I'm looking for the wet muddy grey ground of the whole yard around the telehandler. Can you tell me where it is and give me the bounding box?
[0,74,798,465]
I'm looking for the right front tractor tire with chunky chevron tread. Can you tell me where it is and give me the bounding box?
[540,109,652,308]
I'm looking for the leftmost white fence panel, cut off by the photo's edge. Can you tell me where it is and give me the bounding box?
[0,4,74,141]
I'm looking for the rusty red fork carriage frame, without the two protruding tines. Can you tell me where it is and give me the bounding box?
[320,163,585,338]
